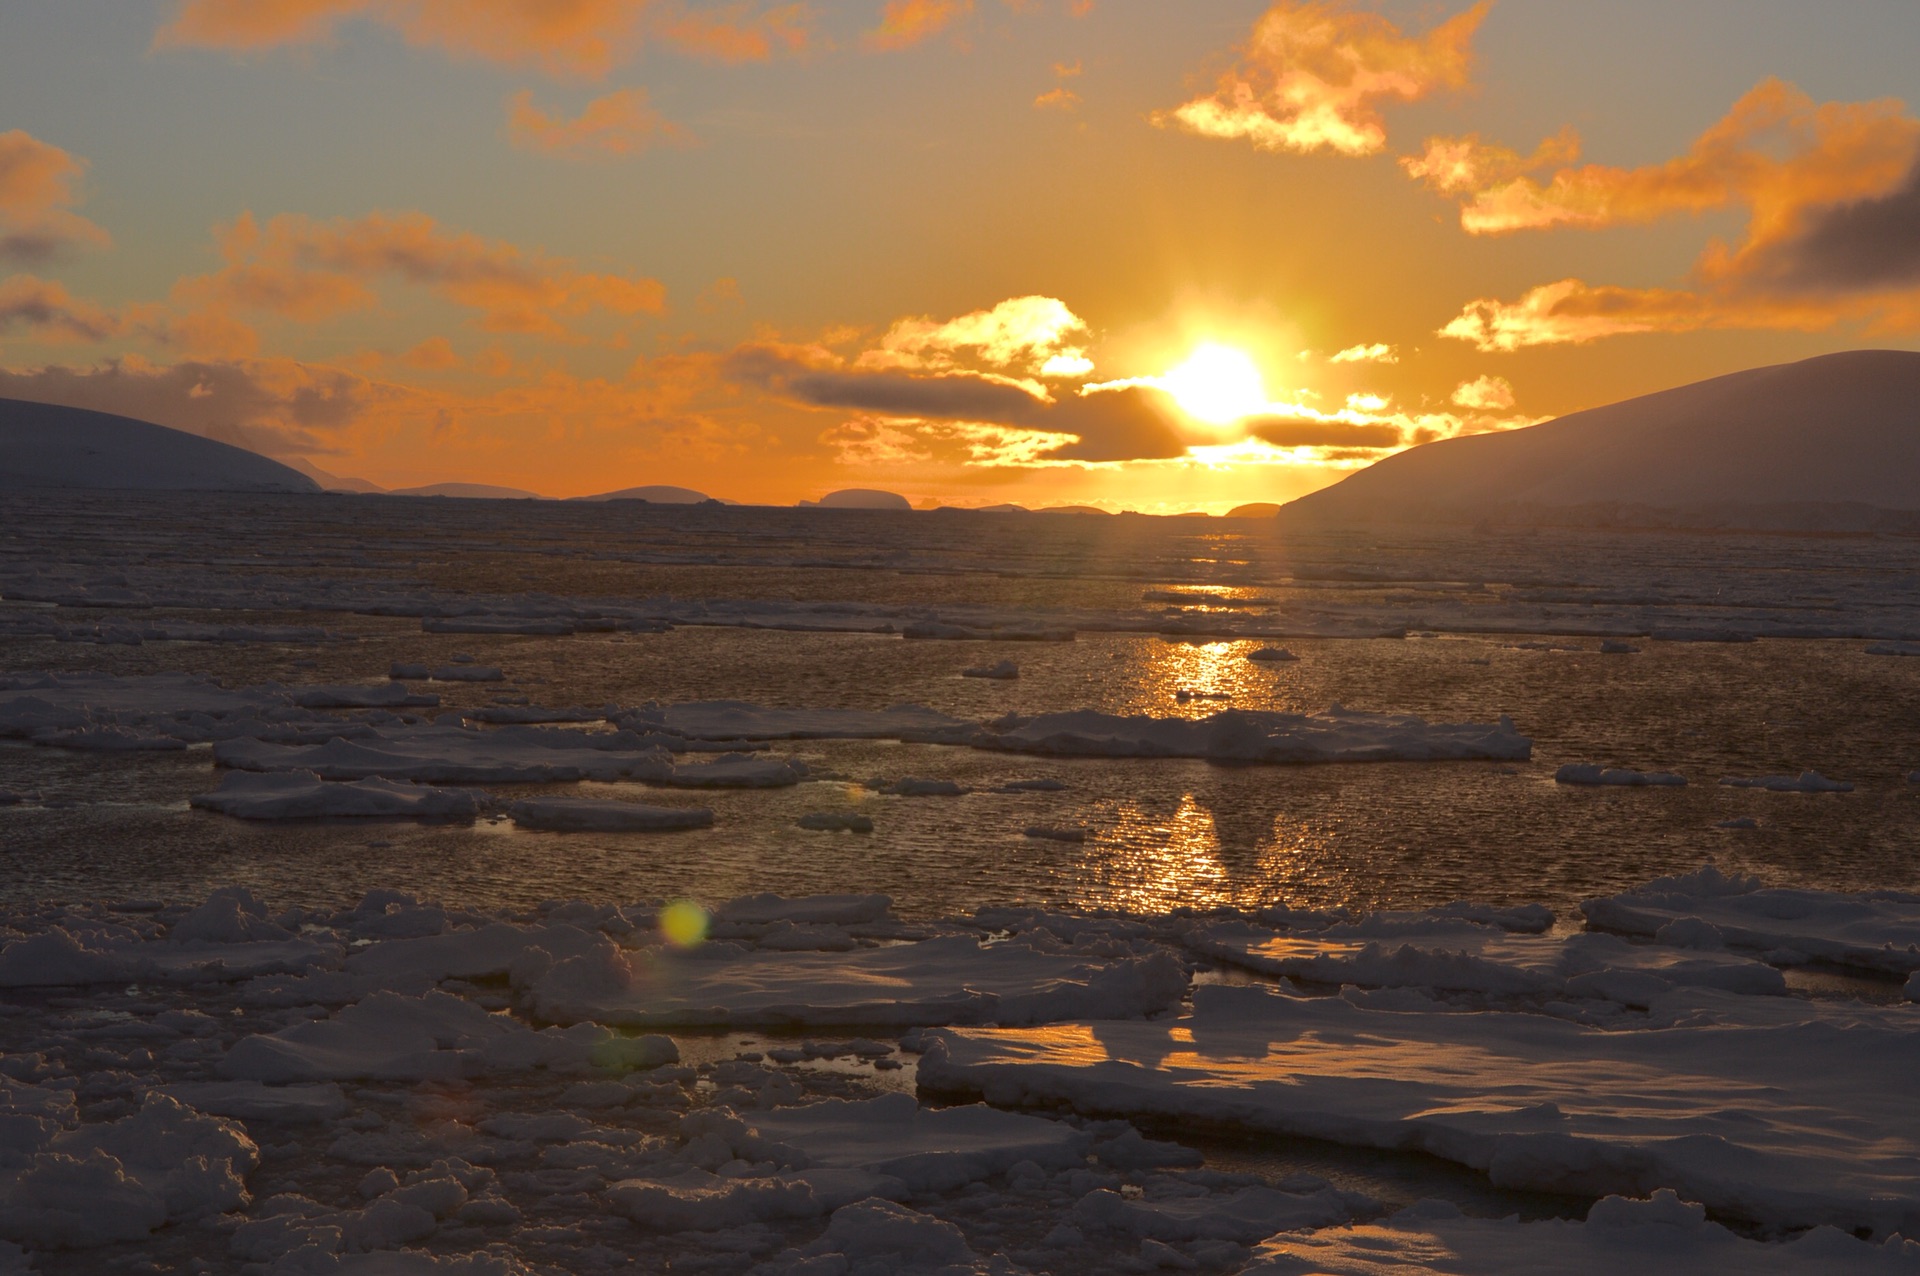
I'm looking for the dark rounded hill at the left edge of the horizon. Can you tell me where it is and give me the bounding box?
[0,399,321,491]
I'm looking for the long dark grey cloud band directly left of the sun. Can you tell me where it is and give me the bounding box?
[724,345,1187,461]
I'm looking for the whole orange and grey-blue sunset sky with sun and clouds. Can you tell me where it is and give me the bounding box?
[0,0,1920,512]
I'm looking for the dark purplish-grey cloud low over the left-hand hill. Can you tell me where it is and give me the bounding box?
[0,361,374,457]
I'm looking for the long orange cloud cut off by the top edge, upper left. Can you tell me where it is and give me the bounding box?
[154,0,812,79]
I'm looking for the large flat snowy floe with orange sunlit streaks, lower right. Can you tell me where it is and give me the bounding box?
[920,984,1920,1236]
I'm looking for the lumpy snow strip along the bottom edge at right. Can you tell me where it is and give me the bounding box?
[1244,1190,1920,1276]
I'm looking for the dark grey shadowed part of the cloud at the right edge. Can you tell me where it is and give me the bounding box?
[1761,163,1920,292]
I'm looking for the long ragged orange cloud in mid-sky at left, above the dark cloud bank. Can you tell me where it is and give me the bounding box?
[173,213,666,336]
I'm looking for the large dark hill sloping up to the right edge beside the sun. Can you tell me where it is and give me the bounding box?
[1281,349,1920,530]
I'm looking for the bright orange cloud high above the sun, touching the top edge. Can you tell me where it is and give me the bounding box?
[1154,0,1492,155]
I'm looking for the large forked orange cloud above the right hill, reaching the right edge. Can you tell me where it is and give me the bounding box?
[1436,81,1920,351]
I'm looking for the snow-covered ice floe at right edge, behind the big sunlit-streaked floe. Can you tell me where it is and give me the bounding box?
[1580,865,1920,975]
